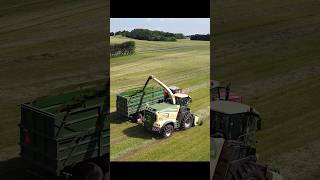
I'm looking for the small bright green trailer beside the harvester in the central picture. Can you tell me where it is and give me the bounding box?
[116,87,164,118]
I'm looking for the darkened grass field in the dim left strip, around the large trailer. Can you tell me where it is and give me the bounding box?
[0,0,108,179]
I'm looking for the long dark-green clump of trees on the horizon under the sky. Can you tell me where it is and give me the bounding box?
[110,29,185,41]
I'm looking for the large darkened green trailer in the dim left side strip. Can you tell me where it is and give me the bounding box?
[19,84,110,180]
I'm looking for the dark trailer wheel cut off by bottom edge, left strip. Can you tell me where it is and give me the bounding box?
[72,162,103,180]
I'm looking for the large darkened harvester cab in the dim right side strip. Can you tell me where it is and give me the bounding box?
[210,100,261,147]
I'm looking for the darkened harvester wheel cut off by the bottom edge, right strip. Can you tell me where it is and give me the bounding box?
[234,162,266,180]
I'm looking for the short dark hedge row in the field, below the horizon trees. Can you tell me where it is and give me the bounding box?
[110,41,135,57]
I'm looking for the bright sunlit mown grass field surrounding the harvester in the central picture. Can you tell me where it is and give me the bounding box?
[110,36,210,161]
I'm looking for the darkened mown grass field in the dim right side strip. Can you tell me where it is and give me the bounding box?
[211,0,320,180]
